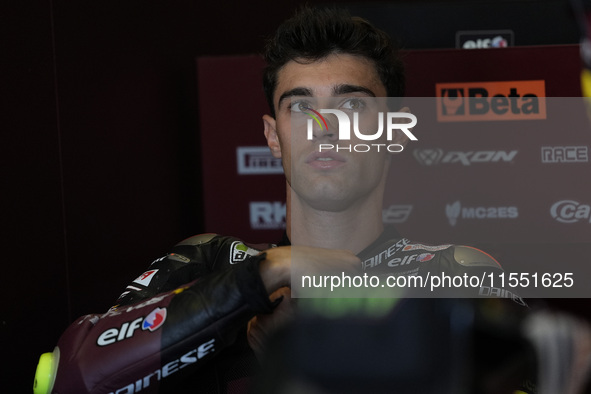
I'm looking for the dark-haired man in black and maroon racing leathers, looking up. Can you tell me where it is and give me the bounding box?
[37,8,528,393]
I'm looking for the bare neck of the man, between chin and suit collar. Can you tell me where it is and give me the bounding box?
[286,186,384,254]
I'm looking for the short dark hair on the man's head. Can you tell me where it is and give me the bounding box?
[263,7,405,116]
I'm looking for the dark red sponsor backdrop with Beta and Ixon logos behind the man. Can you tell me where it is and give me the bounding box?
[197,45,591,286]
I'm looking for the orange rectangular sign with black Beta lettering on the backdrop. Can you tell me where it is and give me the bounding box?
[436,80,546,122]
